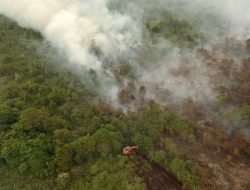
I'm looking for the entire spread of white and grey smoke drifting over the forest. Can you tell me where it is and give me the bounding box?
[0,0,250,108]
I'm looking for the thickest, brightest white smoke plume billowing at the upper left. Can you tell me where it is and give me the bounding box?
[0,0,141,69]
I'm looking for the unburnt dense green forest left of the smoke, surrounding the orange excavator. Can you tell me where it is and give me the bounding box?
[0,16,203,190]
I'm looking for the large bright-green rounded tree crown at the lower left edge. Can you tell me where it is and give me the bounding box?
[1,133,53,177]
